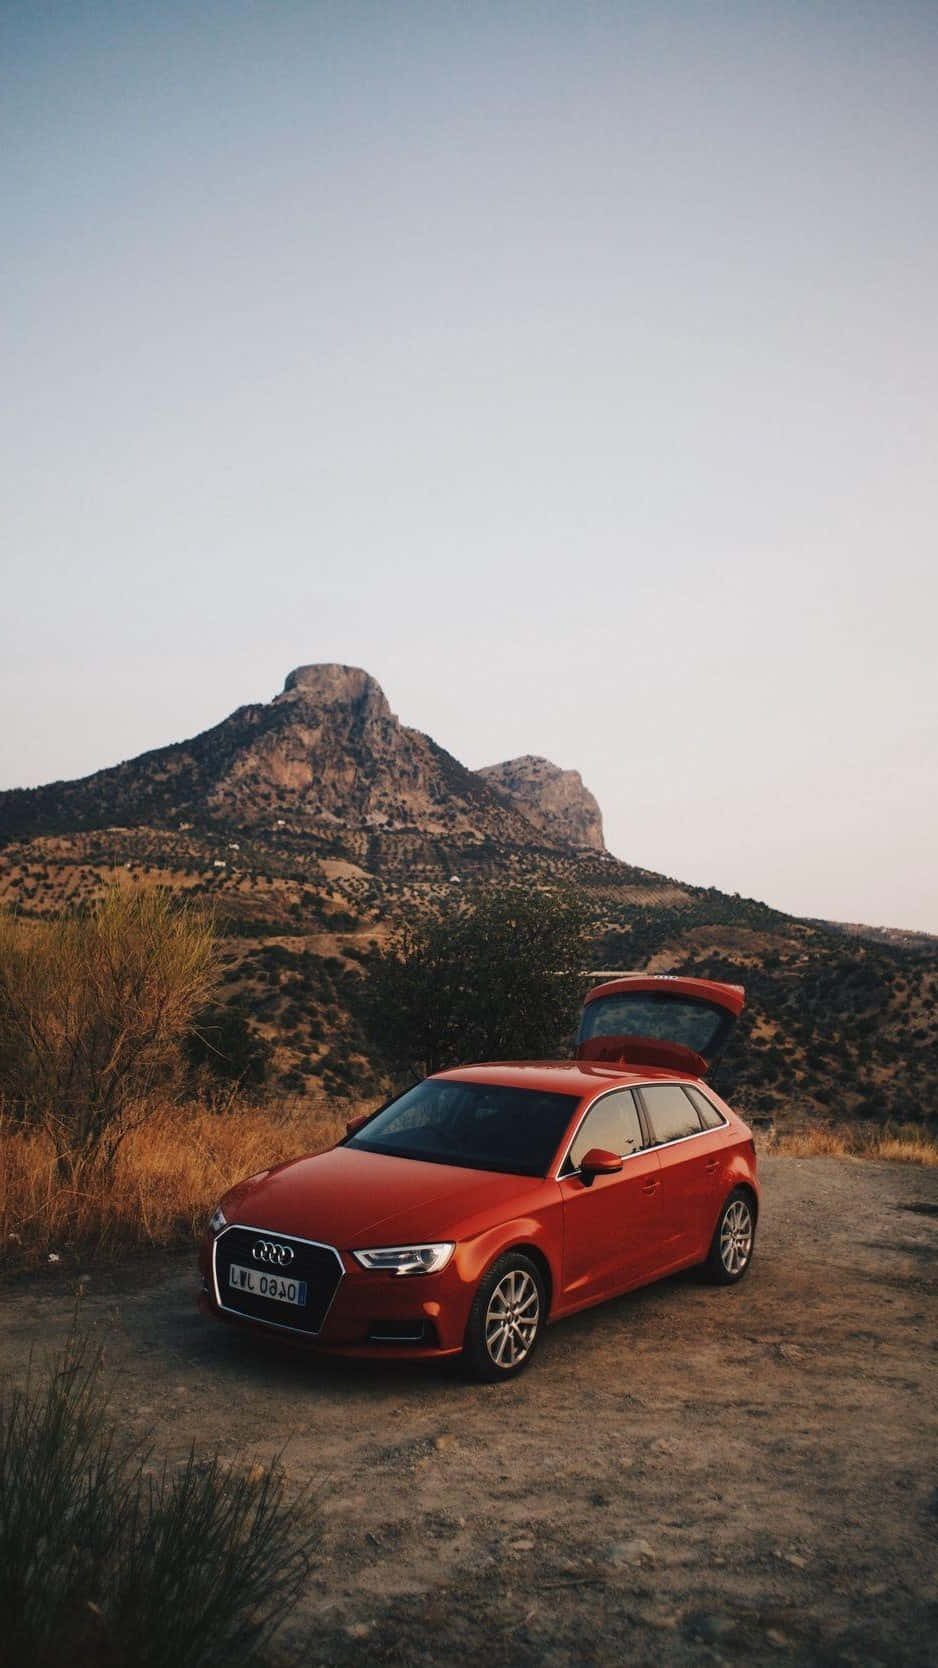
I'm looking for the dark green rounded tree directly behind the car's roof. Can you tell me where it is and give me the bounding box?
[362,886,588,1076]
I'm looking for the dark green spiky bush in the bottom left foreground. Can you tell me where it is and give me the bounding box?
[0,1344,312,1668]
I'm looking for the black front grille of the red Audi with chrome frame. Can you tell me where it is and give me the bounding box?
[215,1228,344,1334]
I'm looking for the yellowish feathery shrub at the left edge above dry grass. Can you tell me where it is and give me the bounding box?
[0,887,217,1174]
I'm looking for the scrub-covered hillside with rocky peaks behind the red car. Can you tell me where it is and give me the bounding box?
[0,666,938,1123]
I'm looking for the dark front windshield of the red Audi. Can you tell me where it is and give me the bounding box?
[345,1078,577,1176]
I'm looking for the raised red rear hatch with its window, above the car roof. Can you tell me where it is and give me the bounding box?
[576,972,746,1078]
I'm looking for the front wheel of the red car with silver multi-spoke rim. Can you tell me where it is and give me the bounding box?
[462,1251,546,1384]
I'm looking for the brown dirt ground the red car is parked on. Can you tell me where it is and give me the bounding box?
[0,1158,938,1668]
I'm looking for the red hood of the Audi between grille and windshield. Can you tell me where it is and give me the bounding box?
[222,1146,541,1249]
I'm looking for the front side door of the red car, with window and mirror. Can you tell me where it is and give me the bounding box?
[557,1089,663,1308]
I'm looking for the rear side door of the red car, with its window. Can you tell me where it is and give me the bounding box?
[639,1083,726,1263]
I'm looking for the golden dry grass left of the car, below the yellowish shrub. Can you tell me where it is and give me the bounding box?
[0,1103,350,1263]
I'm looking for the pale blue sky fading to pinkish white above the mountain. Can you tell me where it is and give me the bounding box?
[0,0,938,932]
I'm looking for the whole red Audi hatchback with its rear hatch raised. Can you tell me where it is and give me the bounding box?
[200,974,759,1381]
